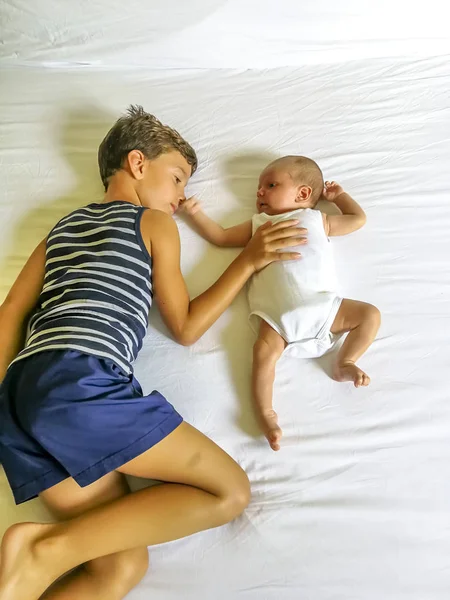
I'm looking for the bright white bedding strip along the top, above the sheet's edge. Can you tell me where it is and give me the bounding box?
[0,0,450,69]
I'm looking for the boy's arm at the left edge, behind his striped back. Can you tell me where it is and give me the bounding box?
[0,240,47,382]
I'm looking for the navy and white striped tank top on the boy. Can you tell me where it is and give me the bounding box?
[14,201,152,374]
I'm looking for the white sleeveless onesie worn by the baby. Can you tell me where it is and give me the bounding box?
[248,208,342,358]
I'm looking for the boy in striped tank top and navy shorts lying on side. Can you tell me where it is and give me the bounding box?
[0,107,299,600]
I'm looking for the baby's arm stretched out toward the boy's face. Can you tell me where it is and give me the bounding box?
[181,196,252,248]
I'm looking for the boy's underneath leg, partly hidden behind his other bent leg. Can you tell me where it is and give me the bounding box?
[41,472,148,600]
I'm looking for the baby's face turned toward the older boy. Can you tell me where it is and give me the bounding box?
[256,165,312,215]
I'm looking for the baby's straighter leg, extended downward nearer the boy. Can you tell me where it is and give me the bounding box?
[252,321,286,450]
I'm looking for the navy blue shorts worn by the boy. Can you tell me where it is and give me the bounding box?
[0,350,183,504]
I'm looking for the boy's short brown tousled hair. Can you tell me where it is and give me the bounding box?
[98,104,197,190]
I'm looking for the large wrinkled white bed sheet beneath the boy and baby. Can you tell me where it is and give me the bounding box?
[0,57,450,600]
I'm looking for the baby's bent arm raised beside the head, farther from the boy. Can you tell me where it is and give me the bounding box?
[323,181,366,236]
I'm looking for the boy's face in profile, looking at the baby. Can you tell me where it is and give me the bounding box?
[137,151,191,215]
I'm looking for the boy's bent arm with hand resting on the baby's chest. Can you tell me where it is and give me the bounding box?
[145,210,304,346]
